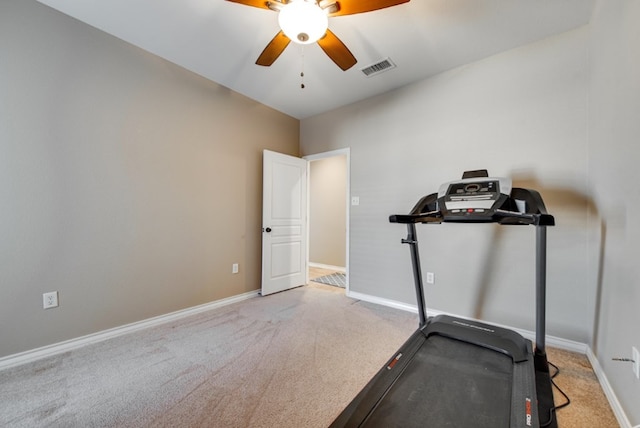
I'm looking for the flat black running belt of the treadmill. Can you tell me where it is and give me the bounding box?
[361,335,513,428]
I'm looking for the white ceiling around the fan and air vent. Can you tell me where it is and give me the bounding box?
[39,0,594,119]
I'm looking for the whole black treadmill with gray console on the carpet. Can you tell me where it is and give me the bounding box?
[331,170,557,428]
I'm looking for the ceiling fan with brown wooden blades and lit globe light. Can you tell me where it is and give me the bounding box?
[227,0,410,71]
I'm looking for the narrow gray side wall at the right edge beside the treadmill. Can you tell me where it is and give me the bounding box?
[587,0,640,425]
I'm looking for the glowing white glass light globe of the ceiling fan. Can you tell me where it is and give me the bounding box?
[278,0,329,45]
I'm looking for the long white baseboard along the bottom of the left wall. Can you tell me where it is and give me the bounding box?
[0,290,260,370]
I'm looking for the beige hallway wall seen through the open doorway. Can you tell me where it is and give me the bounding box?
[309,156,347,268]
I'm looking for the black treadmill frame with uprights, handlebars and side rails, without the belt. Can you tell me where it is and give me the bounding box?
[331,170,557,428]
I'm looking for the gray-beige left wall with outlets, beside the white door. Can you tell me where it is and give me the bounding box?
[0,0,299,356]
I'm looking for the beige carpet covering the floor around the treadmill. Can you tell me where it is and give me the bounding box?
[0,285,617,428]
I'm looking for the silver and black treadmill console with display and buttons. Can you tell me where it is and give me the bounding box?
[438,177,511,222]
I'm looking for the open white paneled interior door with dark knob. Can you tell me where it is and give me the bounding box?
[262,150,307,296]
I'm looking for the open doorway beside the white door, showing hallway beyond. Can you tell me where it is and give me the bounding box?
[304,149,350,292]
